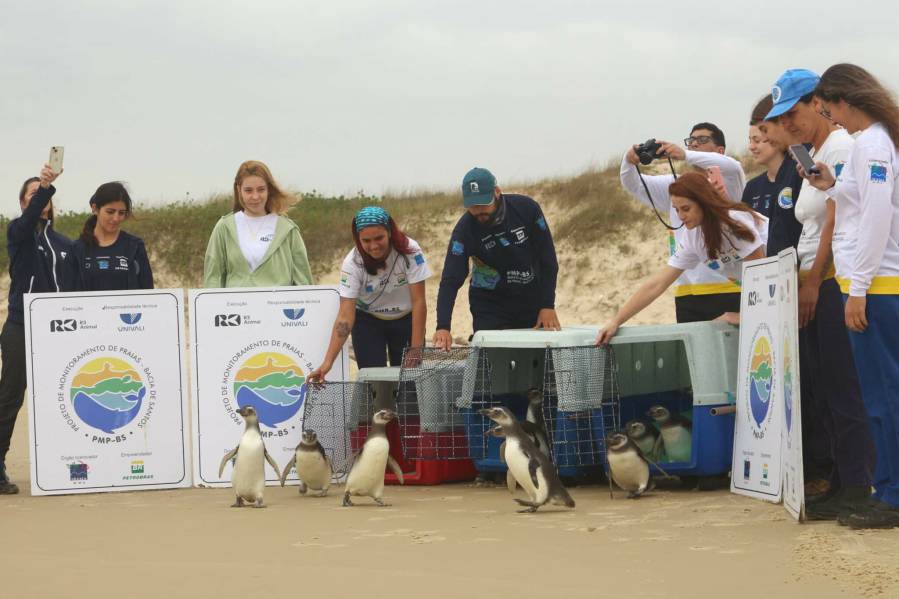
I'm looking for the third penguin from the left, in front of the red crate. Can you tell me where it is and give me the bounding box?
[343,410,404,507]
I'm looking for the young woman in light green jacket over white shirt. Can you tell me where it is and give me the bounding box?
[203,160,312,287]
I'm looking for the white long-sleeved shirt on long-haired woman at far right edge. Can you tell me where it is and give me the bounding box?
[828,123,899,297]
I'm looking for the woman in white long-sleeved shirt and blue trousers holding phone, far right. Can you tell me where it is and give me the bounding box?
[802,64,899,528]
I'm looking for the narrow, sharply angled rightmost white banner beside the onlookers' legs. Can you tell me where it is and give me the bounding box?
[778,248,805,520]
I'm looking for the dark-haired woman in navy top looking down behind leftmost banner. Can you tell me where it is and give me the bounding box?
[65,181,153,291]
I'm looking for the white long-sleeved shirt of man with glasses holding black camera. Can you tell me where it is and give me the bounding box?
[620,150,746,297]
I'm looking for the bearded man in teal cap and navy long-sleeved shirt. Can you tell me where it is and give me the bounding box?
[434,168,559,349]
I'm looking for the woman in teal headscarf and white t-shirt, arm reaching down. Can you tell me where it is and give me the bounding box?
[308,206,431,383]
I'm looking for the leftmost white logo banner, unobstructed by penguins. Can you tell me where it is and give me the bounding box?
[25,289,191,495]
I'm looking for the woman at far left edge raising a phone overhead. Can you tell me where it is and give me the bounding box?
[0,164,72,495]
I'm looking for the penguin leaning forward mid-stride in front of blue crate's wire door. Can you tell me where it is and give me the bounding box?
[480,407,574,512]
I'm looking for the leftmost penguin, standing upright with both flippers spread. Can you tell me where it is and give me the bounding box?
[219,406,281,507]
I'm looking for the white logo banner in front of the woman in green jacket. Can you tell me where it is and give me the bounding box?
[189,286,349,486]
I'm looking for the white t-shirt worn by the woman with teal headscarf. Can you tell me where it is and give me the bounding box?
[338,238,431,320]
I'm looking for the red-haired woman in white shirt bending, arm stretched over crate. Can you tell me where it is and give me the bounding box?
[596,173,768,345]
